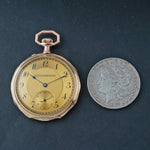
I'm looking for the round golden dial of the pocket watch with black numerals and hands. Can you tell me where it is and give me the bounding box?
[11,55,78,119]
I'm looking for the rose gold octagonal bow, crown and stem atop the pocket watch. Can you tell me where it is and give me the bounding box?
[35,30,60,54]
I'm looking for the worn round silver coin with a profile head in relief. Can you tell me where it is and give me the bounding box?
[87,58,140,109]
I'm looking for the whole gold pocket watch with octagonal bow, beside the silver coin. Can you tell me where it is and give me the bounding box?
[11,30,81,121]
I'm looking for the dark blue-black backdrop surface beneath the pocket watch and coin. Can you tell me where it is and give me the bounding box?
[0,0,150,150]
